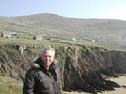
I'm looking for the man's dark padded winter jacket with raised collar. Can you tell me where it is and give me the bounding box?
[23,58,62,94]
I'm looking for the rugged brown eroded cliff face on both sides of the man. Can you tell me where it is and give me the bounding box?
[0,46,126,93]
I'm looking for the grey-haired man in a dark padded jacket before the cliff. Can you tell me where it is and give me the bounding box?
[23,47,62,94]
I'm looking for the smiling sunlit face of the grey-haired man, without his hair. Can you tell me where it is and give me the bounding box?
[43,50,54,69]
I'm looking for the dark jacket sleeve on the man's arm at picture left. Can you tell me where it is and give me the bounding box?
[23,69,35,94]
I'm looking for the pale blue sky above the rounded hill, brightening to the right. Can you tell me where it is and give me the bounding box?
[0,0,126,20]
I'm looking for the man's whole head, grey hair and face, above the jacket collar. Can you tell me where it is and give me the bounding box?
[41,47,55,69]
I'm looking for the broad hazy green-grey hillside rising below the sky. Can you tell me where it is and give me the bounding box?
[0,14,126,48]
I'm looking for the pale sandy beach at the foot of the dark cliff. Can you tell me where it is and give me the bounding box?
[64,76,126,94]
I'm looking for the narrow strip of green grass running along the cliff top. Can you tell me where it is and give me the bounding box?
[0,37,126,51]
